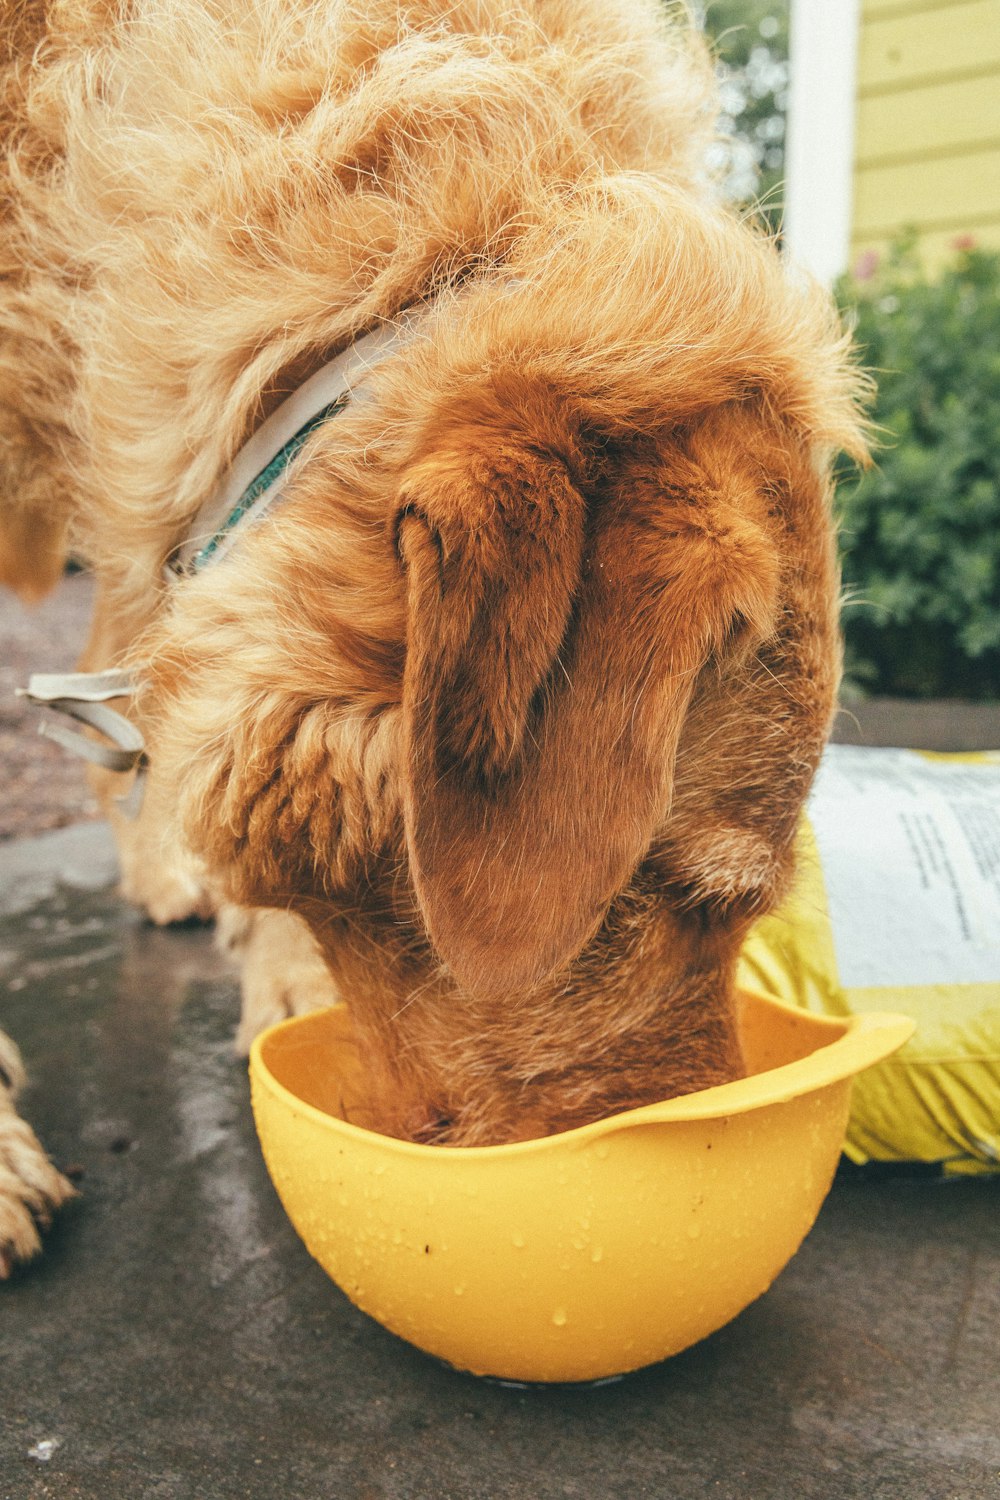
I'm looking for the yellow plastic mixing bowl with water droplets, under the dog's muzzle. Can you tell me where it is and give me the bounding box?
[250,993,913,1380]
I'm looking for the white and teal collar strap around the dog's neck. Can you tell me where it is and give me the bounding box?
[166,312,418,579]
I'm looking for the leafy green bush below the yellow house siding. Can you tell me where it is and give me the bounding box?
[838,245,1000,698]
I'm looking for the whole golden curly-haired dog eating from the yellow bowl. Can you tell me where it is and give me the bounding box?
[0,0,864,1278]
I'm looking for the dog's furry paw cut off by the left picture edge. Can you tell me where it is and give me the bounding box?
[0,1032,76,1280]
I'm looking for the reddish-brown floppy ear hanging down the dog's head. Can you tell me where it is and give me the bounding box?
[397,432,778,995]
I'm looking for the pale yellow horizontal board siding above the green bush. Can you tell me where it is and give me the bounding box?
[851,0,1000,263]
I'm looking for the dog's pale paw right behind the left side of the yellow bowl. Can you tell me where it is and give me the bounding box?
[217,906,339,1058]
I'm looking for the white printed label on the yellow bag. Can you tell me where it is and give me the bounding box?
[807,746,1000,989]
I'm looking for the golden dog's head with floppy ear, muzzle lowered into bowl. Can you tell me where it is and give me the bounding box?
[140,179,861,1140]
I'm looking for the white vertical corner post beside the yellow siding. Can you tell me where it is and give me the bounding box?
[784,0,861,282]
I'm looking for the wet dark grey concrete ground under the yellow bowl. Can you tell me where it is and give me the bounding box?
[0,825,1000,1500]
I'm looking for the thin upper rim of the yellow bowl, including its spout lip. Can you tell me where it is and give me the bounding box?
[249,986,916,1161]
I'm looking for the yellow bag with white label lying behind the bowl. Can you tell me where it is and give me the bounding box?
[741,746,1000,1173]
